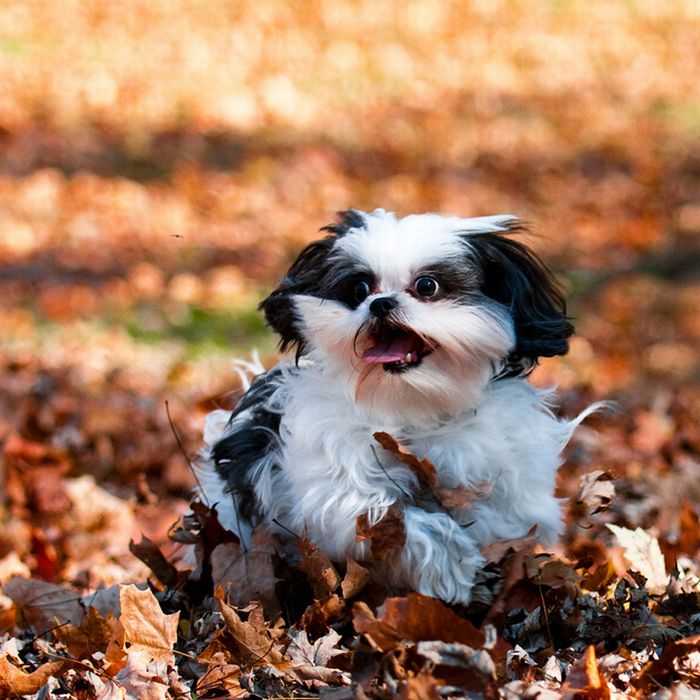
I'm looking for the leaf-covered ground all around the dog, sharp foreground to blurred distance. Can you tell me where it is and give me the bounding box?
[0,0,700,700]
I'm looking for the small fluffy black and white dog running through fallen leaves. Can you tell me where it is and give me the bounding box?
[200,209,592,603]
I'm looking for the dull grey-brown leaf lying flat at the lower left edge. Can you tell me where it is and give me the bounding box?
[2,576,85,633]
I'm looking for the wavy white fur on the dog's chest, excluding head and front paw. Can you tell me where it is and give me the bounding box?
[204,365,575,559]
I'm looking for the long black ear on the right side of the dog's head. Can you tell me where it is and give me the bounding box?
[466,234,574,364]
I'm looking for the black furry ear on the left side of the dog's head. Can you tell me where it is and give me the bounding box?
[259,209,366,359]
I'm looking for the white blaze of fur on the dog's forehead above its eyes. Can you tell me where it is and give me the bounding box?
[335,209,516,292]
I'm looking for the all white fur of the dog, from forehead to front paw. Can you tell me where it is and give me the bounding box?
[199,210,588,603]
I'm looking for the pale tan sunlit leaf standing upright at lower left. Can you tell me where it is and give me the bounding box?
[119,586,180,664]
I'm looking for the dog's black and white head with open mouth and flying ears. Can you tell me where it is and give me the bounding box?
[261,210,573,421]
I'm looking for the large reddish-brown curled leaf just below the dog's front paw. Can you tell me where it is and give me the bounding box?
[353,593,484,651]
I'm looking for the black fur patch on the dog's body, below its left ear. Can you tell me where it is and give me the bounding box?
[212,369,281,525]
